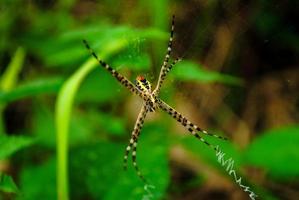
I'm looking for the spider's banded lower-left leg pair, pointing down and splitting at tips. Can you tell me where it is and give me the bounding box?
[124,104,148,182]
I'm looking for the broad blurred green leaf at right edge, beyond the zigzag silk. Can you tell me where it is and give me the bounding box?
[244,126,299,179]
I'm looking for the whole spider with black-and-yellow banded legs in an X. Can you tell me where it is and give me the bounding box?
[83,15,227,182]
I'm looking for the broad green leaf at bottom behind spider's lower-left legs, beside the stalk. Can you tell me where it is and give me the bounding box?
[70,125,169,200]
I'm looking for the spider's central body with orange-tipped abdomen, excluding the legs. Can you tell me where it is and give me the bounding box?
[135,76,158,112]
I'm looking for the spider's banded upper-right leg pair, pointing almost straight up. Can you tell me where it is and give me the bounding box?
[155,15,179,95]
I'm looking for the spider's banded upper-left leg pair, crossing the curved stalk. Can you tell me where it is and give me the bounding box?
[83,40,147,100]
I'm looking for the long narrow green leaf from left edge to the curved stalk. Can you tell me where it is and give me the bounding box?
[0,78,62,103]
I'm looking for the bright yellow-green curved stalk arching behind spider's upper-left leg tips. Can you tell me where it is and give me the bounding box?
[55,39,128,200]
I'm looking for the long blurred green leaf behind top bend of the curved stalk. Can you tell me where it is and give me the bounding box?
[27,23,165,67]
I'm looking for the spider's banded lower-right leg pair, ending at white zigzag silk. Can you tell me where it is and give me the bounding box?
[158,99,227,150]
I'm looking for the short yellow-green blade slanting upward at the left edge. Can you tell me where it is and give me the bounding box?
[0,47,26,135]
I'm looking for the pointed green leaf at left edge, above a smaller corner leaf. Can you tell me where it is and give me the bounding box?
[0,136,33,160]
